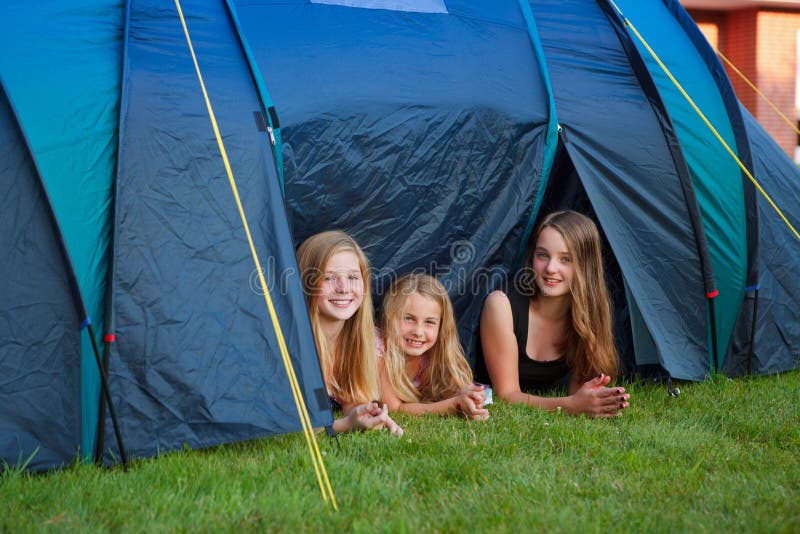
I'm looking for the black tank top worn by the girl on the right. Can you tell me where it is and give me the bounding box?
[475,288,569,391]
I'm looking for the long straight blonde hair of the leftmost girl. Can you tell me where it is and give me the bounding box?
[297,230,379,403]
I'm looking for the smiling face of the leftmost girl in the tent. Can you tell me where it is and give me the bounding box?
[317,250,364,324]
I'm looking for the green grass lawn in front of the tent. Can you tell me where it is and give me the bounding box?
[0,372,800,533]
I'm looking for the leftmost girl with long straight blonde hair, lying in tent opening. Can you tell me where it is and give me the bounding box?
[297,230,402,434]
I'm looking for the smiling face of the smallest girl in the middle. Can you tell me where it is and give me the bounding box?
[398,292,442,356]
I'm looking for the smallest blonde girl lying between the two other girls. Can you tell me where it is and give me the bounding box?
[379,274,489,419]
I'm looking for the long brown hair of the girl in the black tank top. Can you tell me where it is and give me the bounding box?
[527,211,619,381]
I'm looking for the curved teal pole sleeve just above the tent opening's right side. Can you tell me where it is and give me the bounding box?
[514,0,560,268]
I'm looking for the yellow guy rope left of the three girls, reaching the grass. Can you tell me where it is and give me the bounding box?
[175,0,339,510]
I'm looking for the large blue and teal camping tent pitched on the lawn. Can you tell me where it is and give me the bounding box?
[0,0,800,469]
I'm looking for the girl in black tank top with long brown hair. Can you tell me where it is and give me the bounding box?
[478,211,630,417]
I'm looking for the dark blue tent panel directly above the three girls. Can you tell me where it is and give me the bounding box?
[236,0,549,364]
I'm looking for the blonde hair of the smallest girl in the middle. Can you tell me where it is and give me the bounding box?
[381,273,472,402]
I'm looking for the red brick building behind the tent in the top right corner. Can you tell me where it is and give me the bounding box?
[681,0,800,162]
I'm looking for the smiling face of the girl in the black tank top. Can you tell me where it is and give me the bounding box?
[533,227,575,297]
